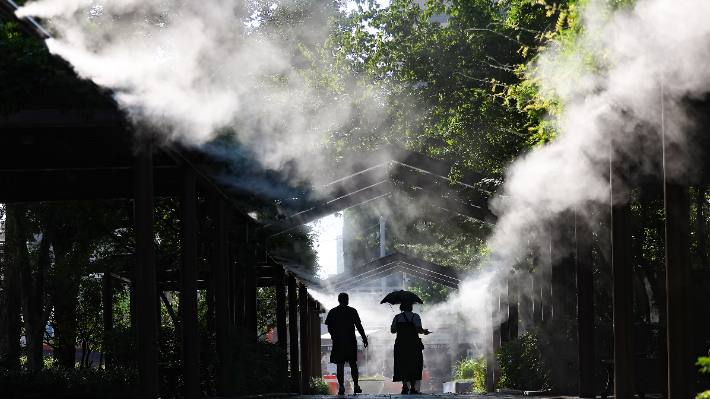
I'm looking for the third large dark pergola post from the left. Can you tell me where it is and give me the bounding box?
[214,197,231,396]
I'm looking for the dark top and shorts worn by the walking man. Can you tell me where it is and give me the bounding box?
[325,305,361,364]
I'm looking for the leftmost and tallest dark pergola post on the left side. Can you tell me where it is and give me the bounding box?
[133,141,158,399]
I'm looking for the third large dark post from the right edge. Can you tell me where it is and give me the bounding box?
[575,206,596,398]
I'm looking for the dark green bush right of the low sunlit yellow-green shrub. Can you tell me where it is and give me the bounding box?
[496,332,552,390]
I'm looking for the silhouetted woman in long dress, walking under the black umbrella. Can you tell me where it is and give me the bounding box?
[390,302,429,394]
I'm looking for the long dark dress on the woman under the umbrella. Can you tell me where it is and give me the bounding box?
[392,315,424,382]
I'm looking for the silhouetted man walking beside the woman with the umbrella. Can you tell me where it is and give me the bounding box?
[325,292,367,395]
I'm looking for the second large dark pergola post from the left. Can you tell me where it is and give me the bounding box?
[180,167,200,399]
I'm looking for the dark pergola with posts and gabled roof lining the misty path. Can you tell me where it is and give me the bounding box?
[0,1,706,399]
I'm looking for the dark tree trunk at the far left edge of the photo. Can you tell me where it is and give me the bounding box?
[0,204,24,369]
